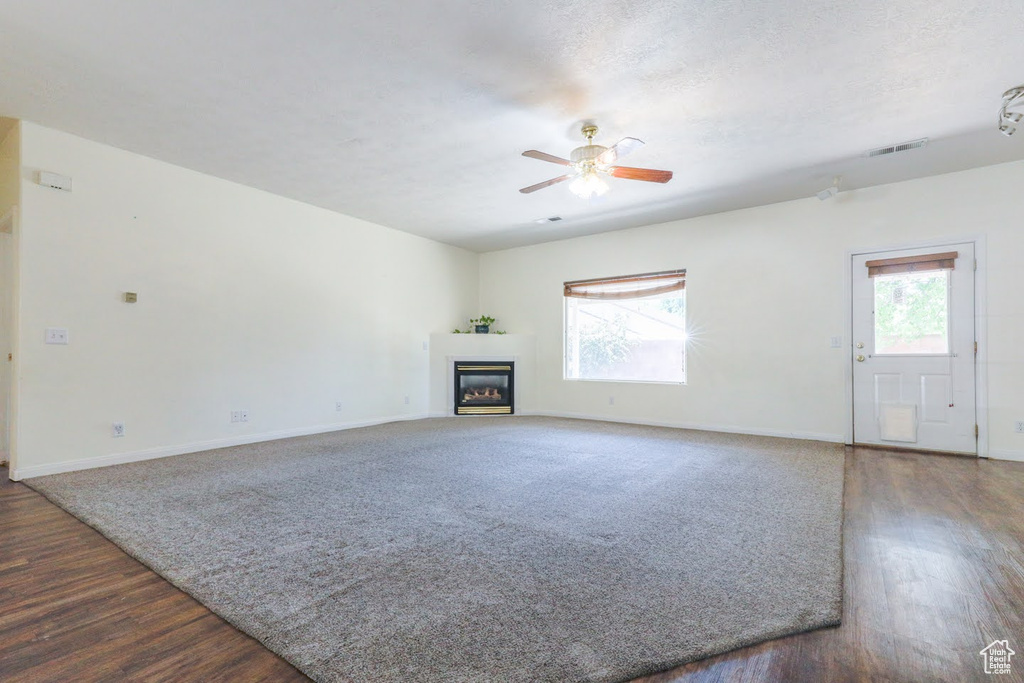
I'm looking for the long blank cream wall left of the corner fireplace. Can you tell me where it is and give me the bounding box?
[14,123,478,476]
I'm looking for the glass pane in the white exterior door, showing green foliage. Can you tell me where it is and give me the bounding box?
[872,270,949,354]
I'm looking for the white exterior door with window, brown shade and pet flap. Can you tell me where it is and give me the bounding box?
[852,244,978,455]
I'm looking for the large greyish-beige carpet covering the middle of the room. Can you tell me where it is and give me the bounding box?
[27,417,843,681]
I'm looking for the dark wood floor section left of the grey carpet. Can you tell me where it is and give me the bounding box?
[0,469,309,683]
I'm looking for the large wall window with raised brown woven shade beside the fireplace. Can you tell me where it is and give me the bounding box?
[564,270,686,383]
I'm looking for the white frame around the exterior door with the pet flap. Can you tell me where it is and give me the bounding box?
[843,233,988,458]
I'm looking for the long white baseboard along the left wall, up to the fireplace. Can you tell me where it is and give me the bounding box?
[10,413,431,481]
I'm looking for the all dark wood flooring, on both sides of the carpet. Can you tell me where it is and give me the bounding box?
[0,449,1024,683]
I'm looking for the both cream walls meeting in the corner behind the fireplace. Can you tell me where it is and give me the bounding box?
[8,123,1024,476]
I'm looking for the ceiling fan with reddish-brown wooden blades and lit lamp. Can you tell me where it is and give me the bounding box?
[519,124,672,199]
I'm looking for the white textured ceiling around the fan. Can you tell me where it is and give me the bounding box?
[0,0,1024,251]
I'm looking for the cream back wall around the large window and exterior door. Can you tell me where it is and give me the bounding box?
[480,162,1024,459]
